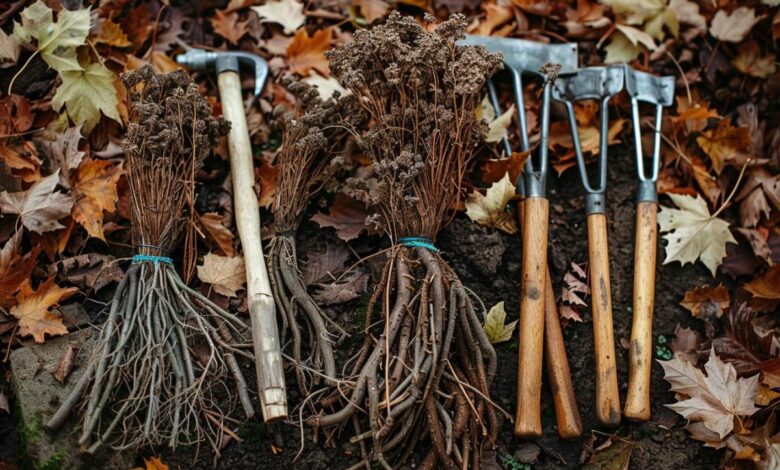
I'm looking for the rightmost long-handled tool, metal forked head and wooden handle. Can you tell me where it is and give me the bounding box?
[623,66,675,421]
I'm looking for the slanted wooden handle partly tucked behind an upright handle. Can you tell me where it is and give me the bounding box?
[544,269,582,439]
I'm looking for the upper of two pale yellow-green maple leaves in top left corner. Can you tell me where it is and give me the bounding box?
[13,0,90,73]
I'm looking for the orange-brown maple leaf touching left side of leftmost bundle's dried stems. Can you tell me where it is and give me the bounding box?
[73,160,122,241]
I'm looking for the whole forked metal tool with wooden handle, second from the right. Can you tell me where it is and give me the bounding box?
[553,66,623,426]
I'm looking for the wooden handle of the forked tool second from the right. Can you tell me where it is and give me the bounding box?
[588,213,620,426]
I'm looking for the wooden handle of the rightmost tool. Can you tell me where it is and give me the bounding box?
[624,202,658,421]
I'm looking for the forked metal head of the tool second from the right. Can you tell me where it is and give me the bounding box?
[552,66,624,214]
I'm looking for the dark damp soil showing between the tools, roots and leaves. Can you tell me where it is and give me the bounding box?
[0,146,728,470]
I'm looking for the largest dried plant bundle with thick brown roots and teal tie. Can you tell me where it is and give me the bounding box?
[307,13,501,469]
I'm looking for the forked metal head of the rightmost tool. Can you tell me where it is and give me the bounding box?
[624,65,675,202]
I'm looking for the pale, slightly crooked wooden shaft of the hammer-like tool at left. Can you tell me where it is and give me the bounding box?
[218,72,287,422]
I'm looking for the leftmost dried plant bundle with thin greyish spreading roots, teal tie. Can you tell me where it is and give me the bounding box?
[47,67,254,453]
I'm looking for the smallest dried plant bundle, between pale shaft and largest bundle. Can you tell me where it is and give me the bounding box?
[269,82,363,396]
